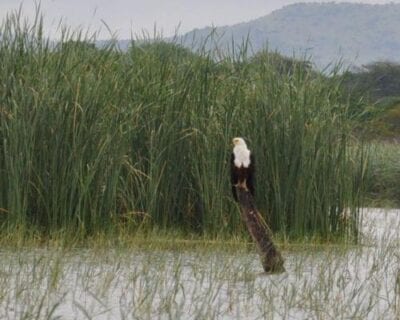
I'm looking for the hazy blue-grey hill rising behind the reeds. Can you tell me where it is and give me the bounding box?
[175,3,400,68]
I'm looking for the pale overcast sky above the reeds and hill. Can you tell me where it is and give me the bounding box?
[0,0,400,39]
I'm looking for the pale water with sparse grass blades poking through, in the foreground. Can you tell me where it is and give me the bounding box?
[0,209,400,319]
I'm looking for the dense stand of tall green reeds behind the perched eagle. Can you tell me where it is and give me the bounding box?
[0,11,364,238]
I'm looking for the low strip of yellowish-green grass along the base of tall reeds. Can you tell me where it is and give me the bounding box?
[0,225,359,252]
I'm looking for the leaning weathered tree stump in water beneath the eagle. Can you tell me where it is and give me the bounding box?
[236,186,285,273]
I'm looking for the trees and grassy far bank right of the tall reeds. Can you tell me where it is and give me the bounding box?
[343,62,400,207]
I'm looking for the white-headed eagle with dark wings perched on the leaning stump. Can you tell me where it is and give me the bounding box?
[231,138,255,201]
